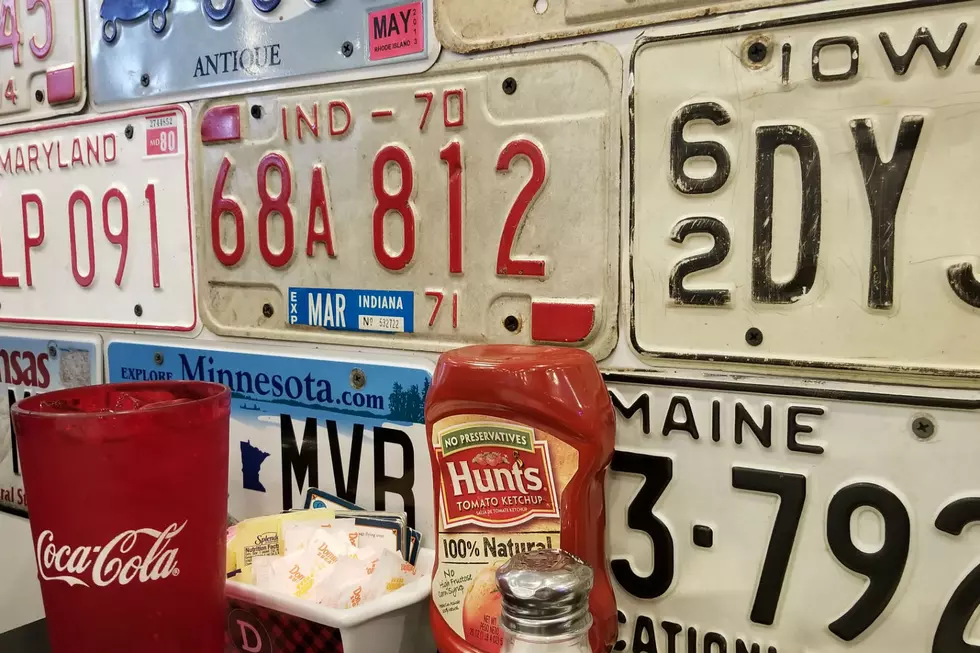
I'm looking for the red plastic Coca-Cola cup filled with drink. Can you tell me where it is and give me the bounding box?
[11,381,230,653]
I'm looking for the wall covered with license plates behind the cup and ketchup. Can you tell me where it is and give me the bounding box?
[0,0,980,653]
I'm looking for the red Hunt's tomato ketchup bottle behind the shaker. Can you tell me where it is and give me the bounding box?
[425,345,617,653]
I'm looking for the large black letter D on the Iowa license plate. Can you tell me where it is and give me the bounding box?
[752,125,821,304]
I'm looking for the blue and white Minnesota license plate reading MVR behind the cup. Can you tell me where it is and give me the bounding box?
[107,340,433,538]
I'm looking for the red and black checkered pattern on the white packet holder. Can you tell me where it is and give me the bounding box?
[225,597,344,653]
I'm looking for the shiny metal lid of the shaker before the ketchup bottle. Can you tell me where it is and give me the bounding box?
[497,549,593,637]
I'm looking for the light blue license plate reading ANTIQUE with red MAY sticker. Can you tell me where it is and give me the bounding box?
[88,0,440,108]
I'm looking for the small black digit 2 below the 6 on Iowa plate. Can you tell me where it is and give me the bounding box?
[668,216,732,306]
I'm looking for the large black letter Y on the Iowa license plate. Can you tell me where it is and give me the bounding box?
[851,116,925,309]
